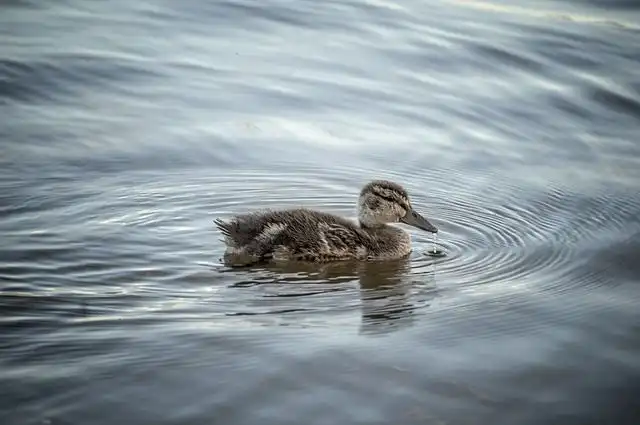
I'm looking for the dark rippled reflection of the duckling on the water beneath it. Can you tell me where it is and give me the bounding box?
[219,257,433,334]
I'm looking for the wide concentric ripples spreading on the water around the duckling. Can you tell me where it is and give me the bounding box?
[2,156,639,334]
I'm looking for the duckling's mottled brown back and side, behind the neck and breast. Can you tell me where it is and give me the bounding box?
[216,208,371,261]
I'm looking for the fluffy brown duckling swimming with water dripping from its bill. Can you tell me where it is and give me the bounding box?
[215,180,438,265]
